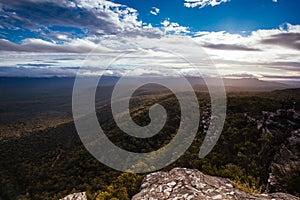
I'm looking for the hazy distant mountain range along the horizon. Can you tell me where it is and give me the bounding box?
[0,76,300,92]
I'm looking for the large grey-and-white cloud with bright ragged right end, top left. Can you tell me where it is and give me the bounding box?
[0,0,142,39]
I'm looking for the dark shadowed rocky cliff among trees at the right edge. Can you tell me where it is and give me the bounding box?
[244,109,300,192]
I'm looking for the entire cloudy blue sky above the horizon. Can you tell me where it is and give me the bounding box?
[0,0,300,82]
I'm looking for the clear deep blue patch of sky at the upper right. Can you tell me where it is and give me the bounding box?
[114,0,300,33]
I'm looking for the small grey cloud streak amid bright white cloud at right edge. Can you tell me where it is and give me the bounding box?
[261,33,300,50]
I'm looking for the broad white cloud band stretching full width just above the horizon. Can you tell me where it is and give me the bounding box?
[0,23,300,81]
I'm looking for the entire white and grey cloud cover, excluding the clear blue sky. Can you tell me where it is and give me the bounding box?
[0,0,300,83]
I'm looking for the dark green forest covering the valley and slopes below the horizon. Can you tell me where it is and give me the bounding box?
[0,88,300,200]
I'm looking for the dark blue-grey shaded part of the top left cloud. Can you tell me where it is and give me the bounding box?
[0,0,120,34]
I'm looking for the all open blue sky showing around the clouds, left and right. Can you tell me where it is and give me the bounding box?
[0,0,300,43]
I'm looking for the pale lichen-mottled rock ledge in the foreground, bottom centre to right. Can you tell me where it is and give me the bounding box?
[132,168,300,200]
